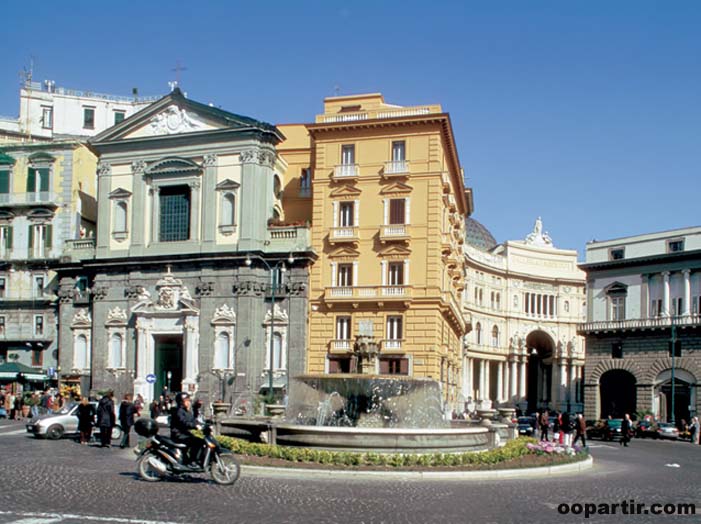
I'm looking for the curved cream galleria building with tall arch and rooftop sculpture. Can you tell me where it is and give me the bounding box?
[462,218,586,413]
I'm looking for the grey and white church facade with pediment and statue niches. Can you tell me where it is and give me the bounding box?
[58,88,313,403]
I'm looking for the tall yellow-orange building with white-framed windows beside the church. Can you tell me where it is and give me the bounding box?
[279,93,472,402]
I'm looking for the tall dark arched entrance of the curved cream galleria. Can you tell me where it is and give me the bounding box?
[526,330,555,413]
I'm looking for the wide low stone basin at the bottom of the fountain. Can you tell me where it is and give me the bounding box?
[274,424,489,453]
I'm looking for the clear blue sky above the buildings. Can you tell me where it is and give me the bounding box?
[0,0,701,253]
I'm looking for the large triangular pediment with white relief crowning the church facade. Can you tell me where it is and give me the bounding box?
[90,88,283,146]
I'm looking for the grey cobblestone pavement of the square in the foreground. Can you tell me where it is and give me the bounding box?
[0,421,701,524]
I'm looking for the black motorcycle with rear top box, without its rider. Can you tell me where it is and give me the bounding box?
[134,419,241,486]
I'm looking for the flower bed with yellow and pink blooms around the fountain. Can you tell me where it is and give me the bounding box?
[213,436,588,470]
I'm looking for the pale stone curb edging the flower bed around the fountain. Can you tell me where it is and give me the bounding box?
[241,456,594,480]
